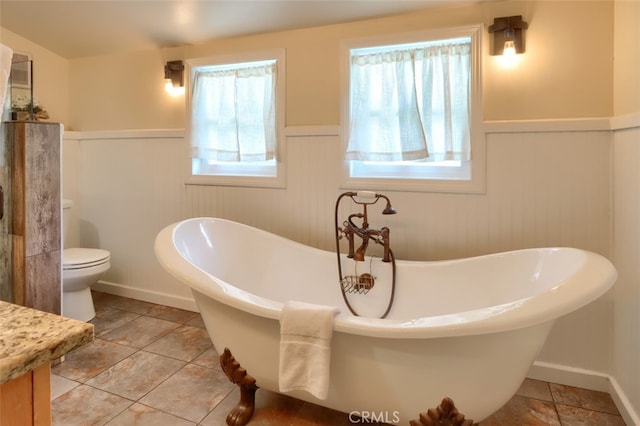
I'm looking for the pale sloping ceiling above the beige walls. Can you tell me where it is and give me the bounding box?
[0,0,452,59]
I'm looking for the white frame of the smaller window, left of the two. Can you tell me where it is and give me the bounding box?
[185,49,287,188]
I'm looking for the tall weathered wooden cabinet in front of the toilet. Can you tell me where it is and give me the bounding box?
[4,121,62,314]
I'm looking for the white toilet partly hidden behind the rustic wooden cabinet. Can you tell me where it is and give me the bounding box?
[62,200,111,321]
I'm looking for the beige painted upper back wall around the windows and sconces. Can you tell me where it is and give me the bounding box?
[69,1,613,130]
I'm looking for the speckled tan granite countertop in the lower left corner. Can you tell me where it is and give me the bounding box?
[0,301,93,384]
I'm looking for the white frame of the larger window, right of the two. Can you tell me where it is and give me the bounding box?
[340,25,486,193]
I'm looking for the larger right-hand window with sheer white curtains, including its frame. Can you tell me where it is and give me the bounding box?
[343,27,484,192]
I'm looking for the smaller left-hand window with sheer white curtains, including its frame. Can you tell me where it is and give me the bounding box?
[187,51,285,187]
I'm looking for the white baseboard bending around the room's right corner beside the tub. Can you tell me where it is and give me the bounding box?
[527,361,640,426]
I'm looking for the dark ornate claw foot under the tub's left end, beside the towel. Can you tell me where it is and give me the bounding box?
[220,348,258,426]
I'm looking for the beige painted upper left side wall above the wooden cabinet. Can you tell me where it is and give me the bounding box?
[0,28,69,124]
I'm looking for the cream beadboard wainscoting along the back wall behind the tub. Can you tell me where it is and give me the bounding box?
[65,122,612,371]
